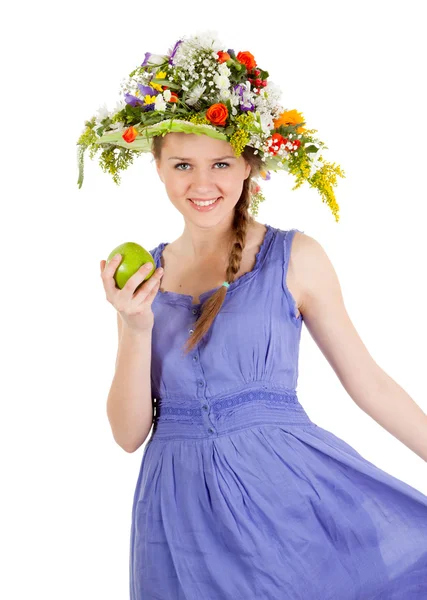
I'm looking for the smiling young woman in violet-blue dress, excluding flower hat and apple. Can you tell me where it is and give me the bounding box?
[89,31,427,600]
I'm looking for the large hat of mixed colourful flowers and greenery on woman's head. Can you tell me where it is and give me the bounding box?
[77,32,345,222]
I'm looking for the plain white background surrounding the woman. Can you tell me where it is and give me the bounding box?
[0,0,427,600]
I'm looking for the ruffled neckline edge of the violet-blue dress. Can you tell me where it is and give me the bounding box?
[154,223,277,307]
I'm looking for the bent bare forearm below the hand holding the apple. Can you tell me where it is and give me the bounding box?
[107,313,153,452]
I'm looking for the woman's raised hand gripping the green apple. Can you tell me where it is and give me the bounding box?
[100,255,163,332]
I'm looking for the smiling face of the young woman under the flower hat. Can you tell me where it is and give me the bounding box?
[156,132,251,223]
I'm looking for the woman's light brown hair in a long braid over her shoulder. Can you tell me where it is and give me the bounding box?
[151,135,264,354]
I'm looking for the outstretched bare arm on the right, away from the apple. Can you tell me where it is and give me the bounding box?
[291,232,427,461]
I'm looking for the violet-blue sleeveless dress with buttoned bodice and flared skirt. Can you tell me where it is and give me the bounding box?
[130,224,427,600]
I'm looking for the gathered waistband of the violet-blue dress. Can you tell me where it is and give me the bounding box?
[145,389,314,443]
